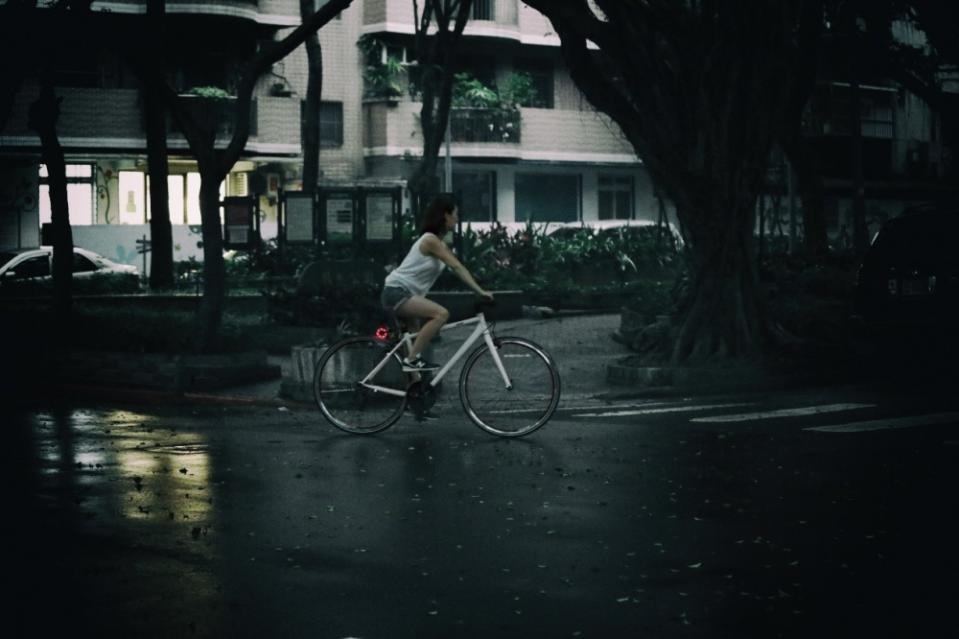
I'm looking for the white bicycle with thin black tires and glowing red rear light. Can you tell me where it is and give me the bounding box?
[313,303,560,437]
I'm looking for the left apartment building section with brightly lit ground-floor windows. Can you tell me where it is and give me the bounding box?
[0,0,302,266]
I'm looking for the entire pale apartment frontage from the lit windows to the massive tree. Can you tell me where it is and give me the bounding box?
[0,0,658,270]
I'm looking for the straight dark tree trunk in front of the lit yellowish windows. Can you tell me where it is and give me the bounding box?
[144,0,173,289]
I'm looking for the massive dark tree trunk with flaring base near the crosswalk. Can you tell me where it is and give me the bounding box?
[527,0,805,361]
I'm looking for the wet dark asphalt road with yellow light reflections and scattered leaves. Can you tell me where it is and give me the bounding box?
[5,387,959,639]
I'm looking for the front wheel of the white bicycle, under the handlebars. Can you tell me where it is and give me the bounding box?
[460,337,560,437]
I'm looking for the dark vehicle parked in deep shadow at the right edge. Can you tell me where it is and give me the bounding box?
[855,207,959,329]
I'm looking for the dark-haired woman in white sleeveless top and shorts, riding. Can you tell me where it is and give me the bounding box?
[380,195,493,372]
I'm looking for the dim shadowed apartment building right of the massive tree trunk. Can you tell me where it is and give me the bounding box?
[765,22,959,244]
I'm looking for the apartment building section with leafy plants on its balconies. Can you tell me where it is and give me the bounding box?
[348,0,658,228]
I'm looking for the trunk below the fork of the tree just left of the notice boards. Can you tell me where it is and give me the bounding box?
[195,175,226,353]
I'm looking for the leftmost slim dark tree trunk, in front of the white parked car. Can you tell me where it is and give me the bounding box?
[29,81,73,322]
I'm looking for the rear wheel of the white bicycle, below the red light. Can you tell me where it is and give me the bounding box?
[313,337,406,434]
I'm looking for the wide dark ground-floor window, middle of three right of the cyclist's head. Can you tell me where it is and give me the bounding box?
[515,173,582,222]
